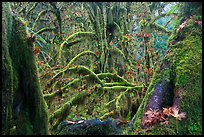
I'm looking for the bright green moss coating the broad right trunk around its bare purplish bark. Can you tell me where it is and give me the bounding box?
[132,19,202,135]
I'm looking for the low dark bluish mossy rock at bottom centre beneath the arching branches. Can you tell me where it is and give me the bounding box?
[58,118,121,135]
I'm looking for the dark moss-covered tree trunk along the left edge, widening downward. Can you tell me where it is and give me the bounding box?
[2,3,48,134]
